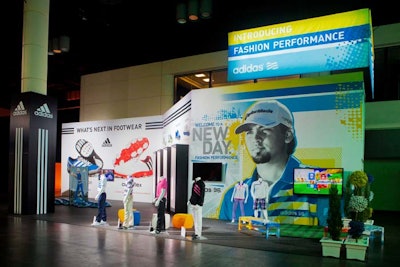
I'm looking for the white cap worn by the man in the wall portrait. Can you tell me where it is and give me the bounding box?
[235,100,293,134]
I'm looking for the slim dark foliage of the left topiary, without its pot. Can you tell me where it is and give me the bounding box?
[326,184,343,240]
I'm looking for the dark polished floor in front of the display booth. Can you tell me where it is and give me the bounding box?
[0,197,400,267]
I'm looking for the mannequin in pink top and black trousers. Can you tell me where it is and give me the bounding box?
[151,177,168,234]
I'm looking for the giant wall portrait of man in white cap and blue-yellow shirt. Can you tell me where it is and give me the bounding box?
[219,100,324,225]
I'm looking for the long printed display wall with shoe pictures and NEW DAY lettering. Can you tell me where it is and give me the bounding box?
[61,72,365,225]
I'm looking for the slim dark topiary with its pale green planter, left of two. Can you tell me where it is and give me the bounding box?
[320,184,343,258]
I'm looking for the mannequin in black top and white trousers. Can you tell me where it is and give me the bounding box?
[187,177,206,240]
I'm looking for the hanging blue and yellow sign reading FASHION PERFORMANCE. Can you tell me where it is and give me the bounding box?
[228,9,373,87]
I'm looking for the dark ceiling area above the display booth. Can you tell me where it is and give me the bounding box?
[0,0,400,114]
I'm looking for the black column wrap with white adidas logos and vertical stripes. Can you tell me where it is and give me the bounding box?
[9,92,57,214]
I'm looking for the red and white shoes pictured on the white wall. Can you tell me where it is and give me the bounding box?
[114,137,153,178]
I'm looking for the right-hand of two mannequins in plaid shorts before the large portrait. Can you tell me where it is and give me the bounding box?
[250,177,269,222]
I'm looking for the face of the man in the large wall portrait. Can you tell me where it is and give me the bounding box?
[245,124,284,163]
